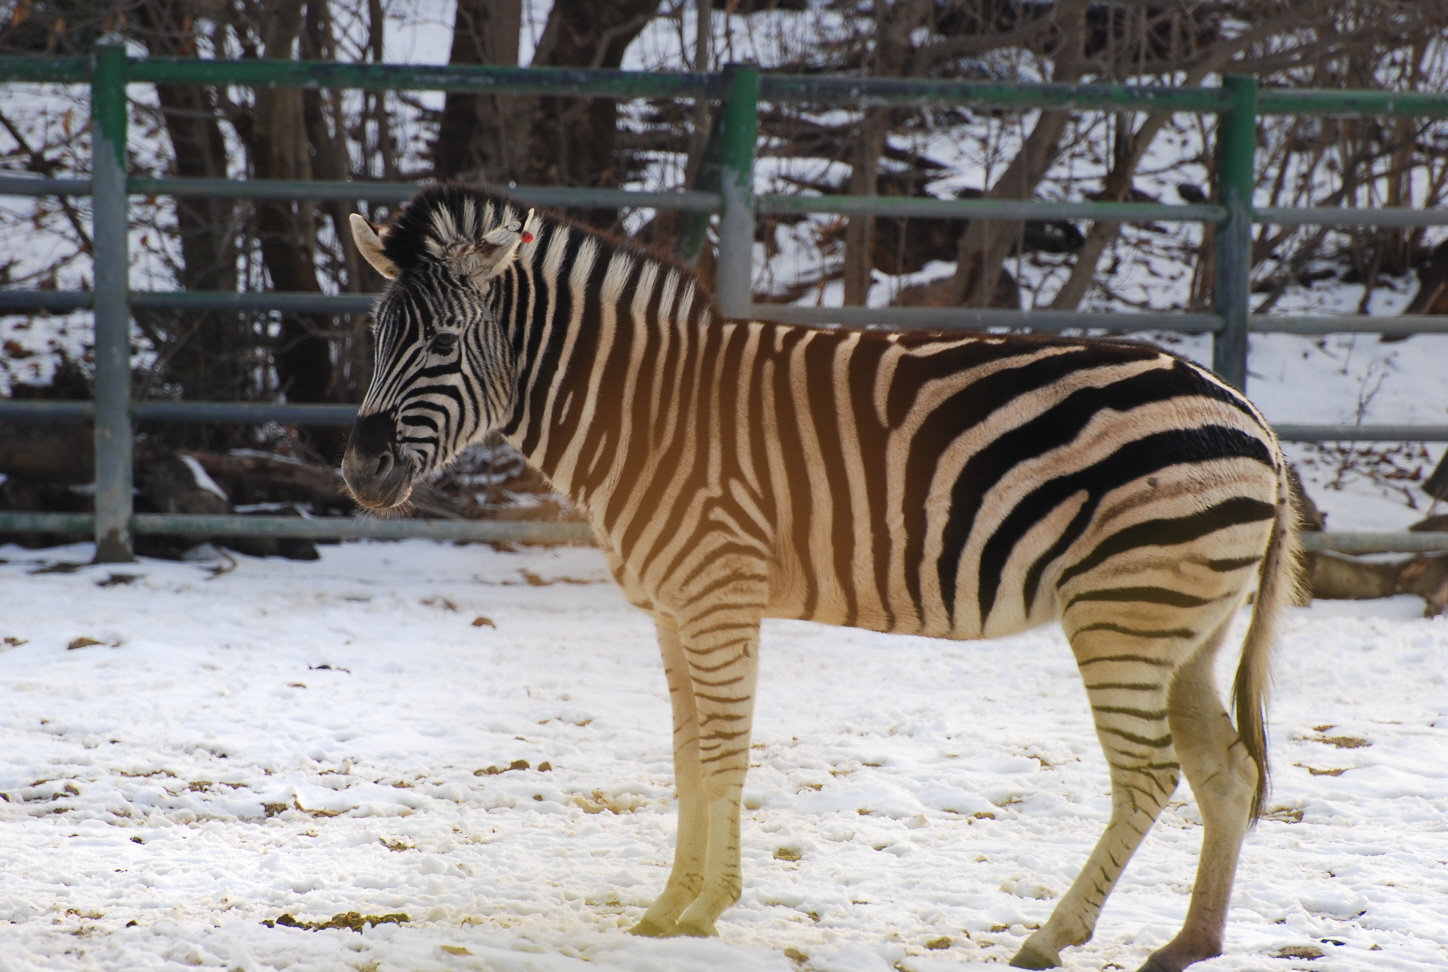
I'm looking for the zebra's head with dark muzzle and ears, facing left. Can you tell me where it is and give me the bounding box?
[342,187,537,510]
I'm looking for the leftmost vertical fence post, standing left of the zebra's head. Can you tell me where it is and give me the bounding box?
[91,45,133,563]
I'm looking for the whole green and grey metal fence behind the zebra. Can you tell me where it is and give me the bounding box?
[0,45,1448,562]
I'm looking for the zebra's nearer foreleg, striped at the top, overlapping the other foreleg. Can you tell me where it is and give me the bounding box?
[663,581,765,936]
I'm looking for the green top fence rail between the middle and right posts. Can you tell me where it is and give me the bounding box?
[759,74,1228,113]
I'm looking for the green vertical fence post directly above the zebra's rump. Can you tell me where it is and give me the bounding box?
[1212,74,1257,391]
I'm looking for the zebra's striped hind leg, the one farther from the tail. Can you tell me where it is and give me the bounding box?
[1011,619,1195,969]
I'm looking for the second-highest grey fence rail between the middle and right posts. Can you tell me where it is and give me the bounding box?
[756,194,1226,223]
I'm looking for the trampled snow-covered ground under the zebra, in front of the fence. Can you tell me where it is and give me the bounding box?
[0,542,1448,972]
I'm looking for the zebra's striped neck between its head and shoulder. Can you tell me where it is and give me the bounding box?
[502,227,710,508]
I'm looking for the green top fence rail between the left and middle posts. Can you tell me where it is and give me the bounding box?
[127,58,727,99]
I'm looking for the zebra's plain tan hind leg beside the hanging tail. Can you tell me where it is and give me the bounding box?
[1141,624,1257,972]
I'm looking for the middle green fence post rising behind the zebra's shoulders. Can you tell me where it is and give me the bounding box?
[715,64,759,317]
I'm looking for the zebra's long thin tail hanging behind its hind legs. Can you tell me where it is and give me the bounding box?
[1232,453,1302,824]
